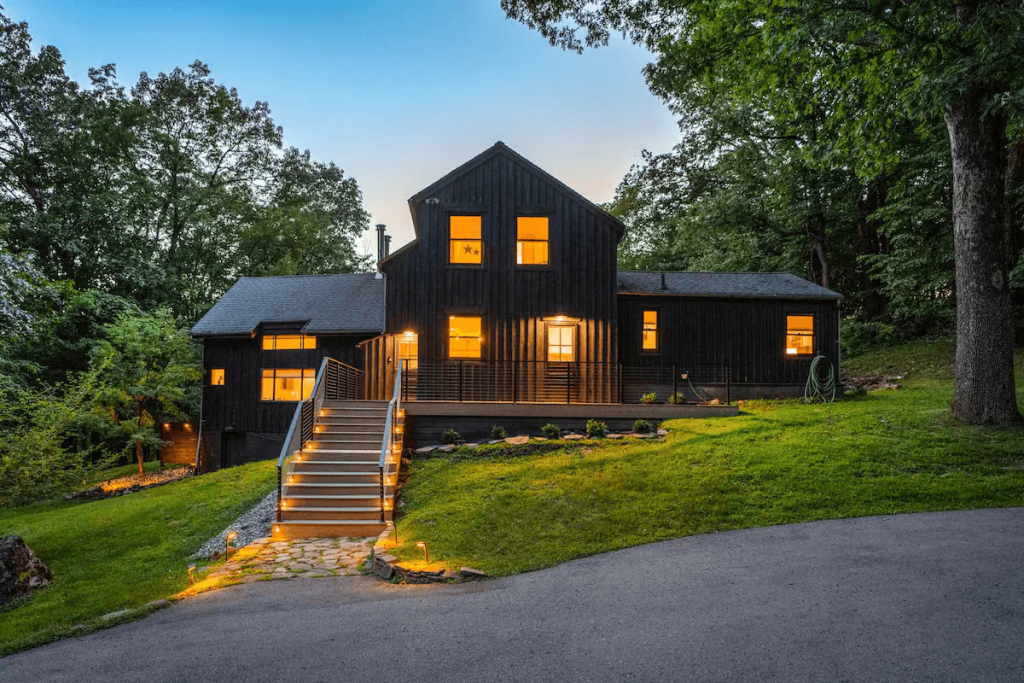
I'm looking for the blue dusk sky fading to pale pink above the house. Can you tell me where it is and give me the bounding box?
[3,0,679,250]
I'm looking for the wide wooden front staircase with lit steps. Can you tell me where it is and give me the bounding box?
[273,399,402,540]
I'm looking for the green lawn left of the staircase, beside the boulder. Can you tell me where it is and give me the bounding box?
[0,461,276,656]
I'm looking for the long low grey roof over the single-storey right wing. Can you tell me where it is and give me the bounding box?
[618,270,843,300]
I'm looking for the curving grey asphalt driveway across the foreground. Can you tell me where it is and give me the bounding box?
[0,508,1024,683]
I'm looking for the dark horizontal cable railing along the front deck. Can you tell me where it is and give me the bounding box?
[400,359,731,403]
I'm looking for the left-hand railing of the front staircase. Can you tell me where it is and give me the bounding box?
[276,358,364,521]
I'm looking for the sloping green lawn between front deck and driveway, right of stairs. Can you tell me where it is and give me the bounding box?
[393,341,1024,574]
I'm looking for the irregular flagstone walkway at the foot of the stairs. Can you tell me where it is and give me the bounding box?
[194,539,376,590]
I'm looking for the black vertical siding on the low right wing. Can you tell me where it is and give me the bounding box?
[618,293,840,396]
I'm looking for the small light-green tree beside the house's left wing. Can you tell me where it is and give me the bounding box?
[92,309,202,474]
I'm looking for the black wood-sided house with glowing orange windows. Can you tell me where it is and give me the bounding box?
[193,142,841,473]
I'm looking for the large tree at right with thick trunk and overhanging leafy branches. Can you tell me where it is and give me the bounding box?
[502,0,1024,424]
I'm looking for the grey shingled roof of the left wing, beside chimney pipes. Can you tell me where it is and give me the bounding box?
[191,272,384,337]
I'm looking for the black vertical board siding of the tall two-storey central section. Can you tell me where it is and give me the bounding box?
[374,148,620,397]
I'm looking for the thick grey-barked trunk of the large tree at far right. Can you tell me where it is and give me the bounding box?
[945,87,1021,424]
